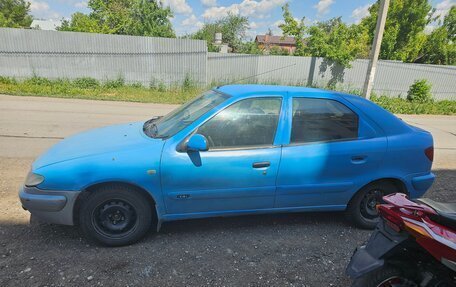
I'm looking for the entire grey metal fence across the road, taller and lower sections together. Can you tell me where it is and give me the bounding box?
[0,28,456,100]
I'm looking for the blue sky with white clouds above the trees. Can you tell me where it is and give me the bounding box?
[29,0,456,38]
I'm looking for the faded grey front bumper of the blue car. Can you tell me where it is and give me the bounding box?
[19,187,80,225]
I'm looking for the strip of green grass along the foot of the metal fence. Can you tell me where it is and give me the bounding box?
[0,76,456,115]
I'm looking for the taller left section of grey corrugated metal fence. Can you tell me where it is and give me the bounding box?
[0,28,207,85]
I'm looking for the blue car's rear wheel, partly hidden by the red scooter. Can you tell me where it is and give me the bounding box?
[347,181,399,229]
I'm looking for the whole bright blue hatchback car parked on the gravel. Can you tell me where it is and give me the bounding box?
[20,85,434,246]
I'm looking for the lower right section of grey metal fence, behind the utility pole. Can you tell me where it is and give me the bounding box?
[208,53,456,100]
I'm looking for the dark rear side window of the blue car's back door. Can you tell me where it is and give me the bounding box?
[290,98,358,144]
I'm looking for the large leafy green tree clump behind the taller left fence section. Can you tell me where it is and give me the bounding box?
[59,0,175,37]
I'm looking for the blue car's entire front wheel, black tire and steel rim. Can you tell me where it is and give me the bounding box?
[79,185,155,246]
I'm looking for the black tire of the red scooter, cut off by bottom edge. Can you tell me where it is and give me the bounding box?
[351,265,418,287]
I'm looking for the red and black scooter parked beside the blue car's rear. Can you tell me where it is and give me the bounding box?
[346,193,456,287]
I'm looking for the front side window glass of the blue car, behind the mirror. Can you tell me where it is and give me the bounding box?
[197,97,282,150]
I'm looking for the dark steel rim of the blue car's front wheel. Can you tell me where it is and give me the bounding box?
[92,199,138,239]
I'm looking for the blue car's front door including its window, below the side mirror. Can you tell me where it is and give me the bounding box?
[161,97,283,215]
